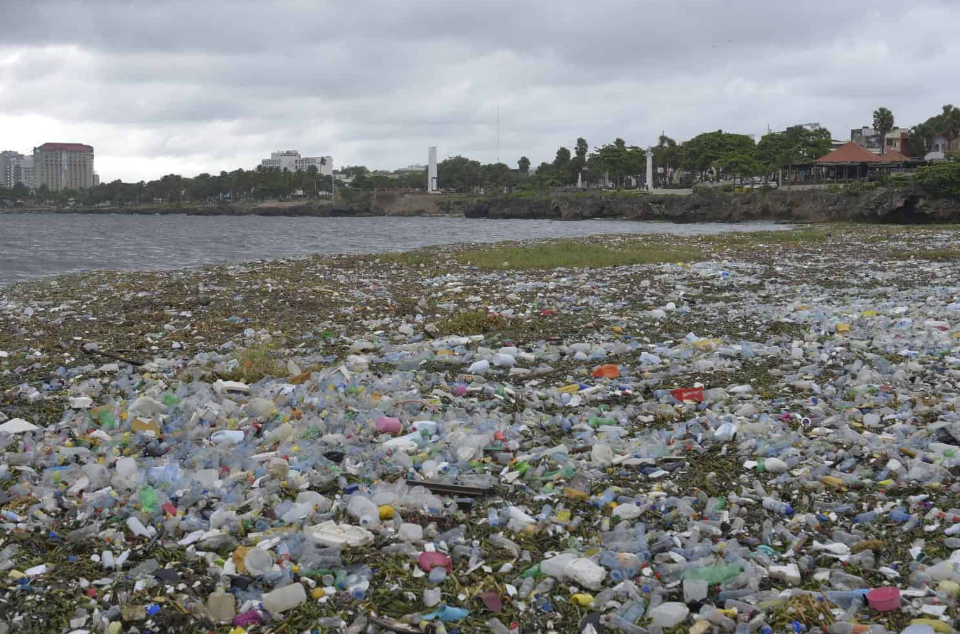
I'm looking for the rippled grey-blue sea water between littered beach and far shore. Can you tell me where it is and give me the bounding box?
[0,214,786,286]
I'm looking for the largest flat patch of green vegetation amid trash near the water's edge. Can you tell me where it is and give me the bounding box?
[455,240,705,270]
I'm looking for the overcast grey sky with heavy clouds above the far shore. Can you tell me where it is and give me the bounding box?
[0,0,960,181]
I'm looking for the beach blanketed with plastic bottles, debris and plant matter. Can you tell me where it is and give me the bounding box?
[0,225,960,634]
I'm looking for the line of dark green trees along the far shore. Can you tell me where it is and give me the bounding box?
[0,104,960,205]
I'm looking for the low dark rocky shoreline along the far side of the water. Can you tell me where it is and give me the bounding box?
[11,188,960,224]
